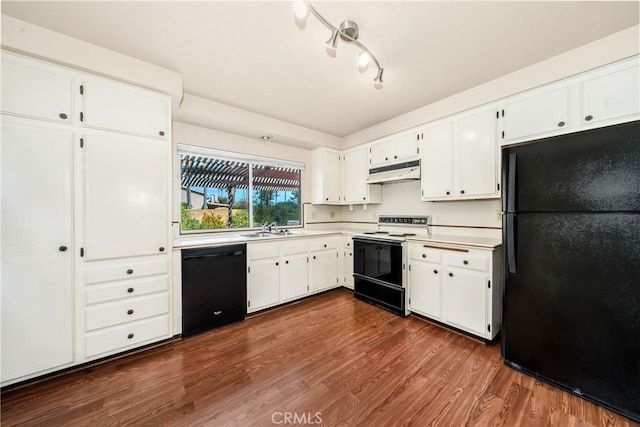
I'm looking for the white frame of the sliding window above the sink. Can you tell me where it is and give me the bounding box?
[177,144,306,235]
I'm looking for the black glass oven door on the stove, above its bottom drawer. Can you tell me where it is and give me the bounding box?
[353,237,403,287]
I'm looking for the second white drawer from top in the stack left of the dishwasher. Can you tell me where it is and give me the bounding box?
[85,275,169,305]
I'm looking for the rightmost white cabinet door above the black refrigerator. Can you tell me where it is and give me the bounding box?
[581,65,640,124]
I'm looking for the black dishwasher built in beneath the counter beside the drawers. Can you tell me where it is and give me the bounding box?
[182,243,247,337]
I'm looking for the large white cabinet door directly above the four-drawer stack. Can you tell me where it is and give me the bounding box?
[83,135,169,260]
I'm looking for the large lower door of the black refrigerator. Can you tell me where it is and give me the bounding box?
[502,213,640,421]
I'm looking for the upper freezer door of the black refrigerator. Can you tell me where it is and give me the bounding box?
[502,121,640,212]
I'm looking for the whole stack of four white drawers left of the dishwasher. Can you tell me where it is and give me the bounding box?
[83,255,171,359]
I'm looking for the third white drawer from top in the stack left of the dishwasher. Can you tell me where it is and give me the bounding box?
[86,293,169,331]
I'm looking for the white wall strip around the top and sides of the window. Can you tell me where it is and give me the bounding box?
[172,121,311,222]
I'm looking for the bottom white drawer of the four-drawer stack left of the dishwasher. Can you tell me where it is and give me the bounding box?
[85,316,169,357]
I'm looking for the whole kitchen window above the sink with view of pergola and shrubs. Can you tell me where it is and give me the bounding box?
[178,145,304,232]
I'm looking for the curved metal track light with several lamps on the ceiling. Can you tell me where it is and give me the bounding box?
[293,0,384,86]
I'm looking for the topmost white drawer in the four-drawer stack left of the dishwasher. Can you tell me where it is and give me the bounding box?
[85,256,169,284]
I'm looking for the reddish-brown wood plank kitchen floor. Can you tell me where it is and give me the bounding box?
[1,290,636,427]
